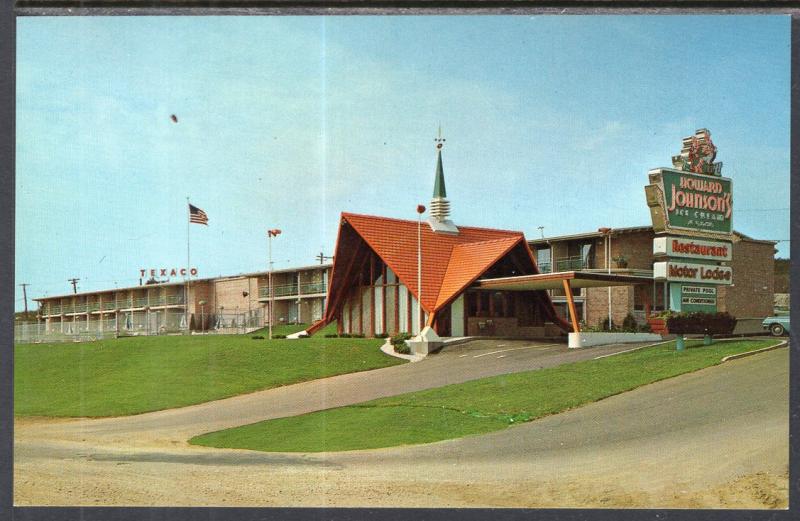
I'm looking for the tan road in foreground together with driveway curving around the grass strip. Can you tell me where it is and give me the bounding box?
[15,343,788,508]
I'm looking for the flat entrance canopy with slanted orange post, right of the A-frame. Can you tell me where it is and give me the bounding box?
[471,271,653,332]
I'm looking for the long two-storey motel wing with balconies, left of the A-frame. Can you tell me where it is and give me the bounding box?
[34,264,331,335]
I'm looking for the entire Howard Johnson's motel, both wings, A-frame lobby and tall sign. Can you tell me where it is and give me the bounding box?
[35,129,776,344]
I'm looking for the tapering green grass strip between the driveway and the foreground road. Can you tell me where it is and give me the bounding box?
[190,339,777,452]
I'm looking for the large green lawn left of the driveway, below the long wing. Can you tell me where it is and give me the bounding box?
[14,335,404,417]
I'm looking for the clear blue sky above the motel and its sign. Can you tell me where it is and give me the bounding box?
[15,15,790,310]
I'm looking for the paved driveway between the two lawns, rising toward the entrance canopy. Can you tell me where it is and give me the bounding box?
[14,340,648,446]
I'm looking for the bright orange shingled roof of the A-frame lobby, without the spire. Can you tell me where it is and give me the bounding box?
[334,213,538,312]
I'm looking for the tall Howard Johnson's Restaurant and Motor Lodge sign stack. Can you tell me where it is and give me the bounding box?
[645,129,733,312]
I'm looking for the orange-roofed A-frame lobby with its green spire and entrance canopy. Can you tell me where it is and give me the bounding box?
[309,146,664,338]
